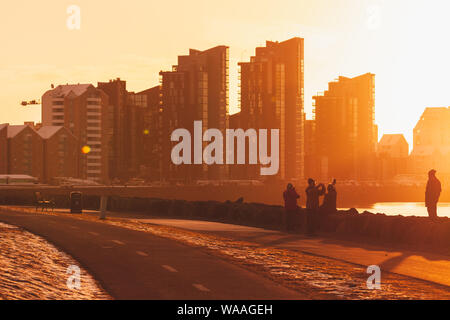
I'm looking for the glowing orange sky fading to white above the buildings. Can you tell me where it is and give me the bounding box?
[0,0,450,148]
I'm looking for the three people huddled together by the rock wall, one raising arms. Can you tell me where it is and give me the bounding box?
[283,178,337,235]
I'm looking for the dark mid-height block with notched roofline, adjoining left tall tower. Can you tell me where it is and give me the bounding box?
[98,78,161,180]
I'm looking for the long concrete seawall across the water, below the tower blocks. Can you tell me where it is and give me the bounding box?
[0,182,450,208]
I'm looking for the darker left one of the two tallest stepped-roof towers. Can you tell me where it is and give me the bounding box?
[160,46,229,181]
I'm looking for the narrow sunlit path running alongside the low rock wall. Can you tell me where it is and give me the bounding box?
[138,219,450,286]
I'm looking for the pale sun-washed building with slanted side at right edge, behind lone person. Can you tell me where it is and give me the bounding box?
[411,107,450,174]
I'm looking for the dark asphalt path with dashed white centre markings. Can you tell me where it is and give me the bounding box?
[0,209,308,300]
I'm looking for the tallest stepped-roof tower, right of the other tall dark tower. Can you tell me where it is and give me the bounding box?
[239,38,305,180]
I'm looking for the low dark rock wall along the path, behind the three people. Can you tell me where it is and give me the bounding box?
[0,193,450,255]
